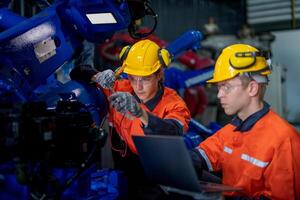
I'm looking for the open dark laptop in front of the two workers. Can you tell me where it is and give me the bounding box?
[133,135,241,192]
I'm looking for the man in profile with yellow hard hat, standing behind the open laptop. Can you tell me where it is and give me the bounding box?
[191,44,300,199]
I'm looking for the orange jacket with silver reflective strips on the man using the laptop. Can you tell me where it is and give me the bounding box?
[198,103,300,200]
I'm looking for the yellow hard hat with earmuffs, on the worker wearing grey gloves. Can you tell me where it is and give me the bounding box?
[119,40,171,76]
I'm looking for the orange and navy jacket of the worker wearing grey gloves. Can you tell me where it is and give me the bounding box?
[103,79,190,154]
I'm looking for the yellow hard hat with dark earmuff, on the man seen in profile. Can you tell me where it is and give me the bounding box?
[207,44,271,83]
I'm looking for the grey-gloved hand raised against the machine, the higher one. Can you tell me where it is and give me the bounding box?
[94,69,116,89]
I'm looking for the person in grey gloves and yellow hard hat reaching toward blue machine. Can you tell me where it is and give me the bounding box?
[71,40,190,199]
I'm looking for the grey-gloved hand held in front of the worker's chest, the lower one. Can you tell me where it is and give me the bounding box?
[108,92,143,117]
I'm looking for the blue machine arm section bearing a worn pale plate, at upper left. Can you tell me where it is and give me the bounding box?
[0,8,75,100]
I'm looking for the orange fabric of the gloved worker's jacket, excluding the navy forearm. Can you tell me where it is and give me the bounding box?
[103,79,190,154]
